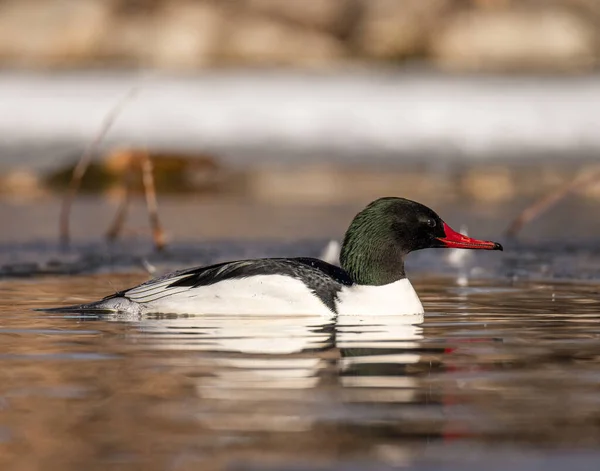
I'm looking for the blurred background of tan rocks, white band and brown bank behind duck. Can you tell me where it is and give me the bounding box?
[0,0,600,251]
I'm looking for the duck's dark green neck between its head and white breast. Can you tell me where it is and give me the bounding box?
[340,238,406,286]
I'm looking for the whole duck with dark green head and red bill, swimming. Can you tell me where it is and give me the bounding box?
[46,197,503,317]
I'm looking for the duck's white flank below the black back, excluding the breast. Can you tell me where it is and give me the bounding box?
[111,275,332,316]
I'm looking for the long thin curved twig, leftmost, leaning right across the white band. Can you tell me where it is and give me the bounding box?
[59,88,138,247]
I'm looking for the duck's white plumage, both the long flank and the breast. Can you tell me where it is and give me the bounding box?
[99,275,424,317]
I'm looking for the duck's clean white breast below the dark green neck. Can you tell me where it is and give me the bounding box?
[337,278,424,316]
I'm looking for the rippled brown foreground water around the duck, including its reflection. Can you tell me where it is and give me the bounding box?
[0,275,600,470]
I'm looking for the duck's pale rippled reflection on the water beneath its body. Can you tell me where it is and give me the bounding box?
[112,315,423,432]
